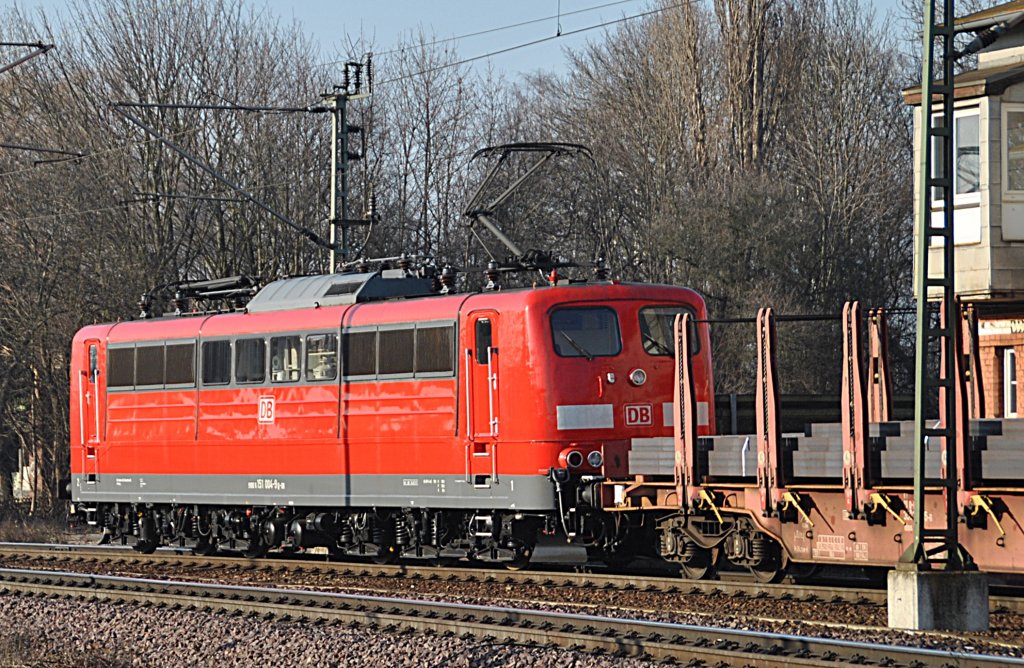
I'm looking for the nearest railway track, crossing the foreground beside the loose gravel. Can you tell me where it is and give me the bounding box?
[0,569,1024,668]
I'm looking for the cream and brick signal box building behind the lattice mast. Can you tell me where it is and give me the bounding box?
[903,0,1024,417]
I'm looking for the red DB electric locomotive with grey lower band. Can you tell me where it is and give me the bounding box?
[71,269,714,563]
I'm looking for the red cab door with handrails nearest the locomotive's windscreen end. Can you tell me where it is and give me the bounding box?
[463,310,501,487]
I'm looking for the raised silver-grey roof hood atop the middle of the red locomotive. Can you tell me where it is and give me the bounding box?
[247,269,436,314]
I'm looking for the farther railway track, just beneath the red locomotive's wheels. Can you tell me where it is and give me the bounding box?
[0,543,1024,614]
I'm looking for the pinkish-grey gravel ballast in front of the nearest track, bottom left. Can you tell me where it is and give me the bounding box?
[0,594,653,668]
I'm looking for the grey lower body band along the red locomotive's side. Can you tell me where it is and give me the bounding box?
[72,473,555,510]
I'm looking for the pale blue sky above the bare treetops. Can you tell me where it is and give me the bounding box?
[19,0,896,78]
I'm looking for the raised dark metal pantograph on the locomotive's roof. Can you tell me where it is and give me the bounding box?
[464,141,593,274]
